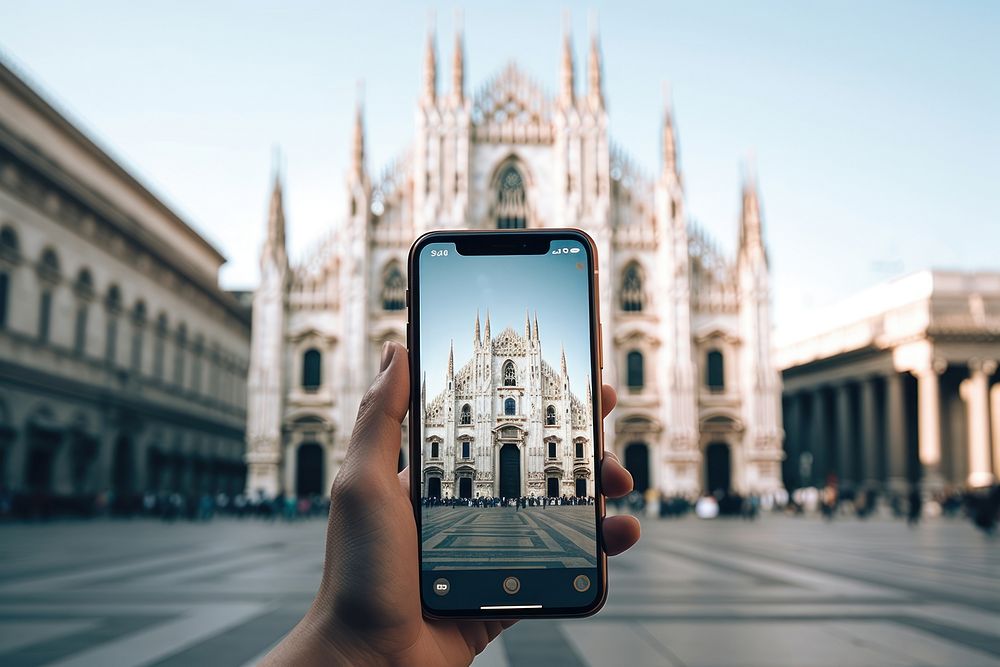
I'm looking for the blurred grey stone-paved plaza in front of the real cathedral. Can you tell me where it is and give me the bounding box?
[0,517,1000,667]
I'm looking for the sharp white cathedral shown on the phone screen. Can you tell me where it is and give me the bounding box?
[420,315,594,498]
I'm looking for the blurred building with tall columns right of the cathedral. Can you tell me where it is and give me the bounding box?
[777,271,1000,495]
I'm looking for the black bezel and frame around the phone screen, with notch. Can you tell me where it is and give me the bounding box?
[406,228,608,619]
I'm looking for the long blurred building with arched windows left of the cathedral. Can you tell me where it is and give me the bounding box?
[0,62,250,512]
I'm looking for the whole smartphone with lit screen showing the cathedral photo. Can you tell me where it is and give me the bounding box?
[407,229,607,619]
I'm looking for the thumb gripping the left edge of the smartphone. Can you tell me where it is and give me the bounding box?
[344,342,410,480]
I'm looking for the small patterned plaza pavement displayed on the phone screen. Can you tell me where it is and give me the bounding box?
[423,505,597,570]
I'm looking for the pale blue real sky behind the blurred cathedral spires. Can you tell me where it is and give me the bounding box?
[0,0,1000,332]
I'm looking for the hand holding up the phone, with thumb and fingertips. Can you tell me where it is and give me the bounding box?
[261,343,639,667]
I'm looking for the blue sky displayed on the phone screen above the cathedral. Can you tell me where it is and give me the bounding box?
[420,241,590,400]
